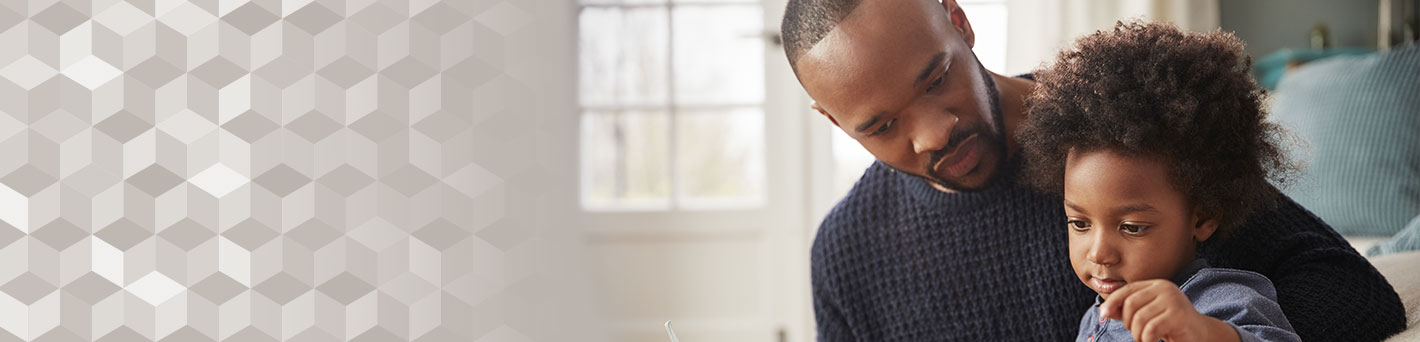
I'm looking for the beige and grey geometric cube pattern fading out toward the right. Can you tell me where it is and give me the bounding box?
[0,0,511,341]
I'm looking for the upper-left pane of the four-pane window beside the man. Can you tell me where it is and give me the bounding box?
[578,7,669,105]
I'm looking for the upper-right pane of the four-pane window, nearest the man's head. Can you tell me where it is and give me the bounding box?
[672,4,765,105]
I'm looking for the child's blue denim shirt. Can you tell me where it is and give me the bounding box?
[1075,258,1302,342]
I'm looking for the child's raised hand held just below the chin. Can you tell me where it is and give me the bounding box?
[1099,280,1238,342]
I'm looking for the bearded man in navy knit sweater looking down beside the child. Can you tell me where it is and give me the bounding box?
[782,0,1404,341]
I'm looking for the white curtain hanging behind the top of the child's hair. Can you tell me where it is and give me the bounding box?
[1005,0,1218,75]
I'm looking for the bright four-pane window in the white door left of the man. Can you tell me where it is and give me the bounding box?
[578,0,767,211]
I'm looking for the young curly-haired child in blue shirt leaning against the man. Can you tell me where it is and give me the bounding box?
[1020,23,1299,342]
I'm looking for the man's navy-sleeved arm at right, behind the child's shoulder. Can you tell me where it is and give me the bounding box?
[1200,197,1404,341]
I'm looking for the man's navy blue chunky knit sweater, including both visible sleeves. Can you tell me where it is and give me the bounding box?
[812,159,1404,341]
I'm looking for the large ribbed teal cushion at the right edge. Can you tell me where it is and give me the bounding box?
[1271,45,1420,236]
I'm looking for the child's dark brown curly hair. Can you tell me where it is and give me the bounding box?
[1018,21,1298,231]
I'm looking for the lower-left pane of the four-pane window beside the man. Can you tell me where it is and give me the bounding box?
[581,111,670,209]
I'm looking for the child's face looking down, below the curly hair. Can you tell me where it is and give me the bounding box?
[1065,150,1217,298]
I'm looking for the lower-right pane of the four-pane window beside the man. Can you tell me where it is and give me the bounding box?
[676,106,765,209]
